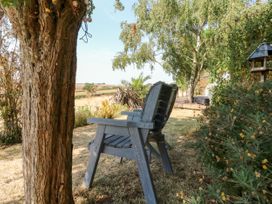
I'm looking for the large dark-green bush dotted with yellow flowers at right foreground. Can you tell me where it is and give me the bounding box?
[197,81,272,203]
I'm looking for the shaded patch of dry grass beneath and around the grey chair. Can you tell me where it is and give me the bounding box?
[73,115,205,203]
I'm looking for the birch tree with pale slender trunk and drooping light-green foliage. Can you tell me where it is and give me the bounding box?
[113,0,232,101]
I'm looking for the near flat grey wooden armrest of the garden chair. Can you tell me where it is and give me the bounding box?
[87,118,154,129]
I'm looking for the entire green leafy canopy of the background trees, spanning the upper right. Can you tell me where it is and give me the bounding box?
[113,0,272,100]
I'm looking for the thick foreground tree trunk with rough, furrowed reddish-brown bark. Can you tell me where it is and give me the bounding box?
[2,0,86,204]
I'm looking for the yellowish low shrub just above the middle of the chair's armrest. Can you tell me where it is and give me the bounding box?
[95,100,125,118]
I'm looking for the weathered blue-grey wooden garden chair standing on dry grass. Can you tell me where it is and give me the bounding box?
[84,82,178,203]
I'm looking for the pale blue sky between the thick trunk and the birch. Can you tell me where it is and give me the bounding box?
[76,0,173,84]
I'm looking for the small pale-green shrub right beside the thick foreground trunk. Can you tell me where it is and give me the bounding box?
[74,106,94,128]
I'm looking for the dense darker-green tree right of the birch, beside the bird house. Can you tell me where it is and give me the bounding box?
[210,1,272,81]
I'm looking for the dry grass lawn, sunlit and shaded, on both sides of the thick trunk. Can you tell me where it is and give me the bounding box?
[0,109,204,203]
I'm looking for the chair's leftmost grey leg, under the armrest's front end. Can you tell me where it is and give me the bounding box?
[83,126,105,188]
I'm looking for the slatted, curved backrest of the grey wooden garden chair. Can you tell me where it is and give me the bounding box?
[142,82,178,131]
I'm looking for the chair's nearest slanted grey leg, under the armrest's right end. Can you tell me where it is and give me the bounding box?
[129,128,157,204]
